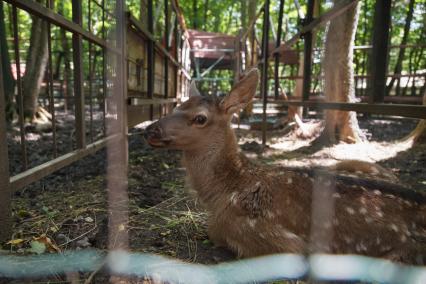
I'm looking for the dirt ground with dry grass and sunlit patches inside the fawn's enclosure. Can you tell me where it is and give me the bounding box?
[0,115,426,283]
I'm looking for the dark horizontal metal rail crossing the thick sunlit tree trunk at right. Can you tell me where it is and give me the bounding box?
[274,100,426,119]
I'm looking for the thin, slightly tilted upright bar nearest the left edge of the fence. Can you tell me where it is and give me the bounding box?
[12,6,28,171]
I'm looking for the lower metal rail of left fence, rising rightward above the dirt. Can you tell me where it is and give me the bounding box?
[10,135,117,191]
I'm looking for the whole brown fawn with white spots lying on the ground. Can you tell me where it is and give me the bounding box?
[145,69,426,264]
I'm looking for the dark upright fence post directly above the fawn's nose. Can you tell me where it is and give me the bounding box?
[147,1,155,120]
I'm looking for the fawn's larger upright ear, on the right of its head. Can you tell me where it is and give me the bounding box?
[220,68,259,114]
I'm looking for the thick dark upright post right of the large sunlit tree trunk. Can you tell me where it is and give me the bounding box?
[369,0,392,103]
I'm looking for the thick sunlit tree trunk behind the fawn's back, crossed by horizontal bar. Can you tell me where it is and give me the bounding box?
[320,0,363,144]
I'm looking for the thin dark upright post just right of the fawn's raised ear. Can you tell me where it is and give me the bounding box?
[260,0,269,146]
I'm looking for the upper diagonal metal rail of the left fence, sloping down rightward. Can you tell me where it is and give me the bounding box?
[4,0,119,53]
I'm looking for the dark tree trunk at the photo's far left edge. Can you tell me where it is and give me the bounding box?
[0,1,15,121]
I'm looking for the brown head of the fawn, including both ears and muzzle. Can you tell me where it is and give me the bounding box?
[145,69,259,151]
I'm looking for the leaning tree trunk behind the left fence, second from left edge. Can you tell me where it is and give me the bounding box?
[22,0,48,121]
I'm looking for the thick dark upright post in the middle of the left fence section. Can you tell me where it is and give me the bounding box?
[72,0,86,149]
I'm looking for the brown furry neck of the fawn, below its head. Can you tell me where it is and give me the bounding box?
[183,128,244,205]
